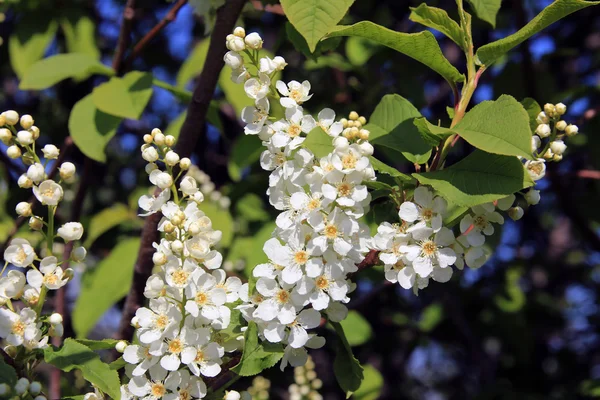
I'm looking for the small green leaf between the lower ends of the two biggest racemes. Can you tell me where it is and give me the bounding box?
[231,322,283,376]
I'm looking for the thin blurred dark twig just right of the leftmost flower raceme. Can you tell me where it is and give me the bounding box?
[49,157,92,399]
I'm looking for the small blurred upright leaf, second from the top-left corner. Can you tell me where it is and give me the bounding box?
[60,11,100,60]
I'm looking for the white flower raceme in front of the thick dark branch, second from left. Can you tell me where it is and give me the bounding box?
[120,129,241,399]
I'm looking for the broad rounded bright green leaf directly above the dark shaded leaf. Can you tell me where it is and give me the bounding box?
[417,95,532,159]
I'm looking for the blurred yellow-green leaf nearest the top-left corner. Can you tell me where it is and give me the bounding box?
[8,12,58,78]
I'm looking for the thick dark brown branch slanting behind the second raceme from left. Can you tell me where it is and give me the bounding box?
[115,0,246,340]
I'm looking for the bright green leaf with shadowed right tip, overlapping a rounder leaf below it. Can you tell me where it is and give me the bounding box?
[92,71,152,119]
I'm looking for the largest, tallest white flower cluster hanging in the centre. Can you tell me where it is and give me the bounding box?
[224,28,375,369]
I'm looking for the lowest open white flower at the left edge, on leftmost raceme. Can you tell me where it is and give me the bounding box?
[0,308,40,346]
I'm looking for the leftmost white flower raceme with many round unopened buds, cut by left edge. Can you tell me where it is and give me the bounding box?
[0,110,86,400]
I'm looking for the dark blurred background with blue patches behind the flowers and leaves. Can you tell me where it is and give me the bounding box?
[0,0,600,400]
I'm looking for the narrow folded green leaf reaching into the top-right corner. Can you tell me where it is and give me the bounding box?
[476,0,600,66]
